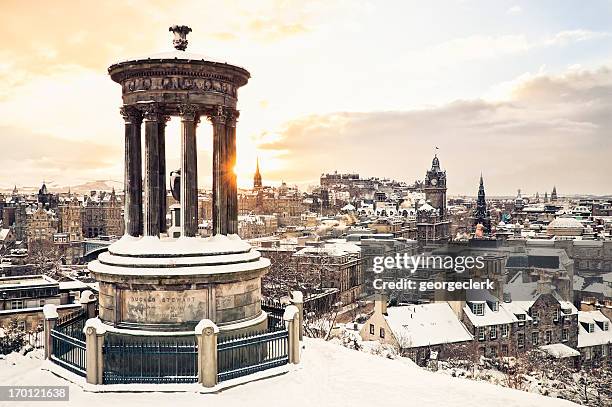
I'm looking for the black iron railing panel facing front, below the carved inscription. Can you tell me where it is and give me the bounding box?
[102,335,198,384]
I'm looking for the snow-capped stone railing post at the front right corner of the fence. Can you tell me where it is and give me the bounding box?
[195,319,219,387]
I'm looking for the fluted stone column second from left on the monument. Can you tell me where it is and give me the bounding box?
[143,104,162,236]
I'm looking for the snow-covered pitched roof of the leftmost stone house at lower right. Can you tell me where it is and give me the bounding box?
[385,303,473,348]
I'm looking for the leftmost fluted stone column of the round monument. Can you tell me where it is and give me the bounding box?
[120,106,142,236]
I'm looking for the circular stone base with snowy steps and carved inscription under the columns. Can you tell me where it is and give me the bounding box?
[89,235,270,332]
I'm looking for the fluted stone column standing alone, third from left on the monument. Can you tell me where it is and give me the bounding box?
[179,104,199,237]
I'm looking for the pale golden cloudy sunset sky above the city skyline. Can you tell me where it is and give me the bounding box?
[0,0,612,195]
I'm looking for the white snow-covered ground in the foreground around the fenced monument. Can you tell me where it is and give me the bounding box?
[0,339,575,407]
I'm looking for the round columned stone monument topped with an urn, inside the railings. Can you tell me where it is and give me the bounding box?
[89,26,270,332]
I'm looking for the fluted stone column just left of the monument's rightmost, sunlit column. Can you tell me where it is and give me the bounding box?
[210,105,228,235]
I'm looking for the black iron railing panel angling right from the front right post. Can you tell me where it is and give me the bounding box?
[217,330,289,382]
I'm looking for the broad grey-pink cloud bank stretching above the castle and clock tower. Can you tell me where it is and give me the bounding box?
[260,68,612,194]
